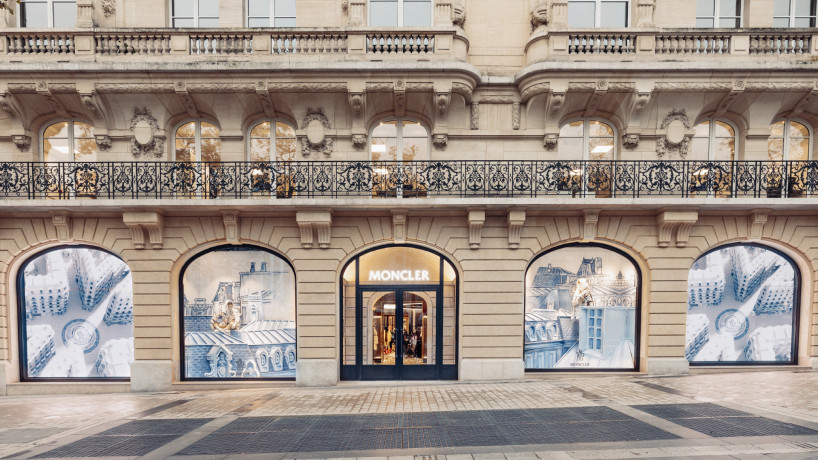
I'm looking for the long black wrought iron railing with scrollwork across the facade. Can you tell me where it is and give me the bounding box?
[0,161,818,200]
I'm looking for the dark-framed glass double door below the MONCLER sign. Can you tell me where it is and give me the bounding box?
[359,288,442,379]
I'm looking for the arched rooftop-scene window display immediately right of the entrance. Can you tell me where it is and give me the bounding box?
[524,245,639,369]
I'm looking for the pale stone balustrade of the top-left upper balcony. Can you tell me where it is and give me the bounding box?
[0,27,468,62]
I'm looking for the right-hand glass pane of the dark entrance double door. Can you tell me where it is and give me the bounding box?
[401,291,438,366]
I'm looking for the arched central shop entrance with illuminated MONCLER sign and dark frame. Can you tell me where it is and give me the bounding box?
[341,246,457,380]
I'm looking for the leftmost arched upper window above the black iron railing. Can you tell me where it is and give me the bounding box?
[42,121,97,162]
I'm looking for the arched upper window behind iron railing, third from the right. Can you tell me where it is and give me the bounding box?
[559,119,616,161]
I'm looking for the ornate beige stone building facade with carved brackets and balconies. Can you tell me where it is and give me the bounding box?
[0,0,818,394]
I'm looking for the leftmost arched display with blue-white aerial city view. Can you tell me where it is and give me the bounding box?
[21,248,134,379]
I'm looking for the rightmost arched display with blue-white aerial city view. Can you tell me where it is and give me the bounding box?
[685,245,797,364]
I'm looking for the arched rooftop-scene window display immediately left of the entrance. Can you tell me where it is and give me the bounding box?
[181,247,296,379]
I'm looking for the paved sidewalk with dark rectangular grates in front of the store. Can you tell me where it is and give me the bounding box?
[0,370,818,460]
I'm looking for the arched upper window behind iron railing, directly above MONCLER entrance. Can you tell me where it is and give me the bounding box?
[370,118,429,161]
